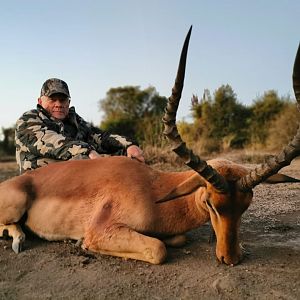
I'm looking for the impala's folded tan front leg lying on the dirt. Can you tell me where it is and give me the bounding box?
[82,224,167,264]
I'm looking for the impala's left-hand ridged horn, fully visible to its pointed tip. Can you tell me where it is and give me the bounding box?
[163,26,228,193]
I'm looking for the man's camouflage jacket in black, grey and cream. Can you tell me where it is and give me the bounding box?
[15,104,133,173]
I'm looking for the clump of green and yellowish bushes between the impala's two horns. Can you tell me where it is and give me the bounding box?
[190,85,299,153]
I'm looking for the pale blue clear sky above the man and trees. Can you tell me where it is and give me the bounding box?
[0,0,300,128]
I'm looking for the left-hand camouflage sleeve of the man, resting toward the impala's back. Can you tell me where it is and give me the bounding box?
[16,112,93,160]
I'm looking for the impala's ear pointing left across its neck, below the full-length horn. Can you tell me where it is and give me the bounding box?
[156,174,206,203]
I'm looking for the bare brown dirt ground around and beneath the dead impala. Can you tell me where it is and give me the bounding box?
[0,159,300,300]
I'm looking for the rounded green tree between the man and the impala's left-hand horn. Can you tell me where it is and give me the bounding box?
[100,86,167,145]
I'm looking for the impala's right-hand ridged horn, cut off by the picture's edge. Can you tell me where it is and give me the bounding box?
[237,44,300,191]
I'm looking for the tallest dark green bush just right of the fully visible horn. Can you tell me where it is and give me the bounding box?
[192,85,251,150]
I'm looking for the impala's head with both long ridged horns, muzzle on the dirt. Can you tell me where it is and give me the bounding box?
[161,27,300,265]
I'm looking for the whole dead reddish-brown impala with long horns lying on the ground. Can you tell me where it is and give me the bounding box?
[0,29,300,264]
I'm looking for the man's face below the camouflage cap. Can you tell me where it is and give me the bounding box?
[38,94,70,120]
